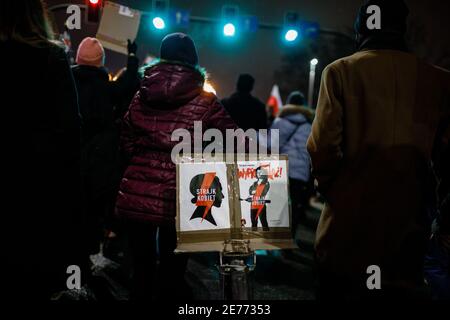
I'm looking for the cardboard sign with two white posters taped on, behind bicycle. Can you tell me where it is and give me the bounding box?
[177,156,295,252]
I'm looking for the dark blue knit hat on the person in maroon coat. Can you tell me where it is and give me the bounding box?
[160,33,198,66]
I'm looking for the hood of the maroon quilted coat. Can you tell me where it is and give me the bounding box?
[139,62,205,109]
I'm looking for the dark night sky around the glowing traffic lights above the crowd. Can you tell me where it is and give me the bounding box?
[47,0,450,100]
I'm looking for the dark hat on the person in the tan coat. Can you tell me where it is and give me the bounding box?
[355,0,409,36]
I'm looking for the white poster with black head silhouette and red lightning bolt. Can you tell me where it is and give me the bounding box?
[179,162,230,232]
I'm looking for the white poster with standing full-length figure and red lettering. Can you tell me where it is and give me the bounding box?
[238,160,289,231]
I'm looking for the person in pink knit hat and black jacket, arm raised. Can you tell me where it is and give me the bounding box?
[72,37,139,254]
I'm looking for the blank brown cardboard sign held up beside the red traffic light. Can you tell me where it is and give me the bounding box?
[96,1,141,54]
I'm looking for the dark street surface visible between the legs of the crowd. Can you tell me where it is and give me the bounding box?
[87,205,320,300]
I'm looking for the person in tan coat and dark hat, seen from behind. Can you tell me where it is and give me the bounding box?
[307,0,450,299]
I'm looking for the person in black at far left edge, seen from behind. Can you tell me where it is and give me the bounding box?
[0,0,89,300]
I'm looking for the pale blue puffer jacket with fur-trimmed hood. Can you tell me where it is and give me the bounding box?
[271,105,314,182]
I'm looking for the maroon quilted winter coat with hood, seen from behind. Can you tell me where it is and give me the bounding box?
[116,63,236,224]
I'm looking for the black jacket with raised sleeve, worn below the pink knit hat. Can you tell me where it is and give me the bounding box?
[72,56,138,199]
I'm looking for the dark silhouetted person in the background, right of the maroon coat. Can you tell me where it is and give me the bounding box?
[222,74,268,130]
